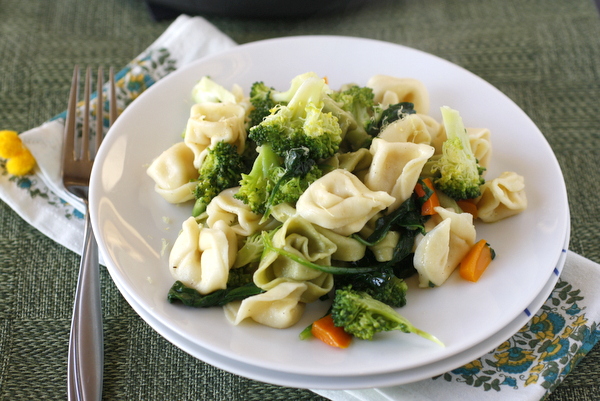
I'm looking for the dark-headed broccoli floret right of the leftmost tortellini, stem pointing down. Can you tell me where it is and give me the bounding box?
[192,142,246,217]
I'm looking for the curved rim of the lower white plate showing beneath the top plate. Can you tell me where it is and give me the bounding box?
[101,225,569,390]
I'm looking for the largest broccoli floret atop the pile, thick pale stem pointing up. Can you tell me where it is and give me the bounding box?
[248,77,342,160]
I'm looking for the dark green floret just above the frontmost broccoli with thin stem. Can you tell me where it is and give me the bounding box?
[335,267,408,308]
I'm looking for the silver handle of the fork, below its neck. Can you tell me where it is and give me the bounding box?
[67,205,104,401]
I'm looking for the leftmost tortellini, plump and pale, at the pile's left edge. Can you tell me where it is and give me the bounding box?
[146,142,198,203]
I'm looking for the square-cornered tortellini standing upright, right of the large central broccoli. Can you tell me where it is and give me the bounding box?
[364,138,434,212]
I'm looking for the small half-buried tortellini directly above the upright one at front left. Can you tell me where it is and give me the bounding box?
[206,187,262,237]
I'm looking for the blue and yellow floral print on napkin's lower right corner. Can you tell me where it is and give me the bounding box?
[433,280,600,391]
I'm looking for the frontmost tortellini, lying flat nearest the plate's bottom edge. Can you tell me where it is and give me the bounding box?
[224,282,307,329]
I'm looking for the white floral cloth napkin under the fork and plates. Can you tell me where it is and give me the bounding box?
[0,15,600,401]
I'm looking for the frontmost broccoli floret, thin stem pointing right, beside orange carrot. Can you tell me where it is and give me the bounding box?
[331,287,443,346]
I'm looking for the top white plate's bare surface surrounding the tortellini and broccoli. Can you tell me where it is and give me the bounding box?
[90,36,568,376]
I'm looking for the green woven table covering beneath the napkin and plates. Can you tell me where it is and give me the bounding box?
[0,0,600,401]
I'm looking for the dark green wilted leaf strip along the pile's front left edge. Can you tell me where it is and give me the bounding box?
[167,281,264,308]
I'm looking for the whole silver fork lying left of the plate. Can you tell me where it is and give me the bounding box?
[62,66,117,400]
